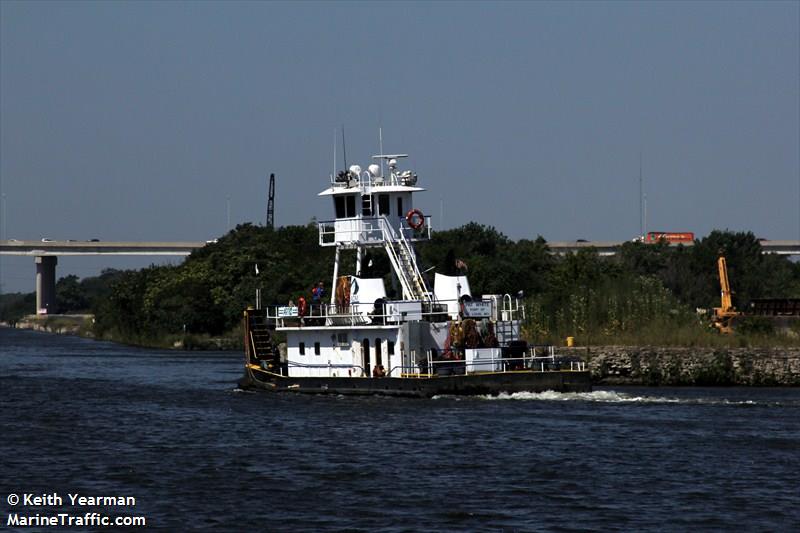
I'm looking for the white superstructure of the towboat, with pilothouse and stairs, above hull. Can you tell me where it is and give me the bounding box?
[265,154,524,377]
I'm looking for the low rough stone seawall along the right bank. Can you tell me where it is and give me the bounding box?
[567,346,800,387]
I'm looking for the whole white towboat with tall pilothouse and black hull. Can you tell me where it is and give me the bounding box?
[239,154,591,397]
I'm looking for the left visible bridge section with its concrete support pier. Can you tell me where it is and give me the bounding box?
[0,240,206,315]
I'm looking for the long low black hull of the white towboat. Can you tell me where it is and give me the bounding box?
[239,368,592,398]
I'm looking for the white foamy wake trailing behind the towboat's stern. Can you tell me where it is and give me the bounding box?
[434,390,792,407]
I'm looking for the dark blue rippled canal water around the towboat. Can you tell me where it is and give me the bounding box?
[0,328,800,531]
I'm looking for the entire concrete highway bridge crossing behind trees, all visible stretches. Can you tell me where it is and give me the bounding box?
[0,240,800,314]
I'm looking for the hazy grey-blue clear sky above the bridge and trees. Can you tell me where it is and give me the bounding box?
[0,0,800,292]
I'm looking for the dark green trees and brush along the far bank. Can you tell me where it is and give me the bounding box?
[0,221,800,345]
